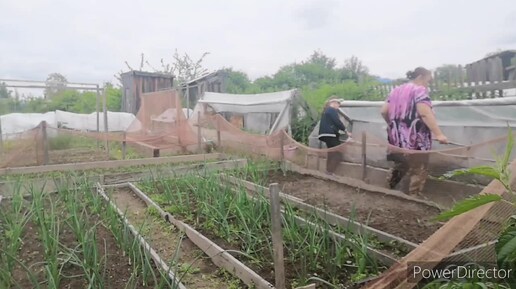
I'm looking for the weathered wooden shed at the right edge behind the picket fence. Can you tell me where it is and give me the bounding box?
[466,50,516,83]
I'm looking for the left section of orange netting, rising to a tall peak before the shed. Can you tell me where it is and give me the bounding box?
[0,90,199,168]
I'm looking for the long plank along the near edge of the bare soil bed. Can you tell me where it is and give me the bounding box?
[221,174,418,250]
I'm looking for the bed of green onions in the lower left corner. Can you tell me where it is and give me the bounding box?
[0,183,177,289]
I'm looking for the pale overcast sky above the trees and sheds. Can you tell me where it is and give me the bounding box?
[0,0,516,83]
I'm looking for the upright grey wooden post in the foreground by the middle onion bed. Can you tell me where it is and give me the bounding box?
[269,183,285,289]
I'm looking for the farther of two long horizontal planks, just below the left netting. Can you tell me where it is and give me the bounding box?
[0,153,222,176]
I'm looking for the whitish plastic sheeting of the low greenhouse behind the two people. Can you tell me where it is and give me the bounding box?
[309,97,516,149]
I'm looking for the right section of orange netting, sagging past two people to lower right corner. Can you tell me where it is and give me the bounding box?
[192,110,516,288]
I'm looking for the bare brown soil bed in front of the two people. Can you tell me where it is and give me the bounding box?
[265,171,440,243]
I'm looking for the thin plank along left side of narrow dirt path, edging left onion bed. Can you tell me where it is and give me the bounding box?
[96,183,186,289]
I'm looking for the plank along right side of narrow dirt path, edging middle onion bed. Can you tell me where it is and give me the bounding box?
[129,183,274,289]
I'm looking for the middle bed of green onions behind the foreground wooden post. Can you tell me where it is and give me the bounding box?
[133,175,392,288]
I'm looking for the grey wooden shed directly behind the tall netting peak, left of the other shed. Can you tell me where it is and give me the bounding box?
[121,70,174,114]
